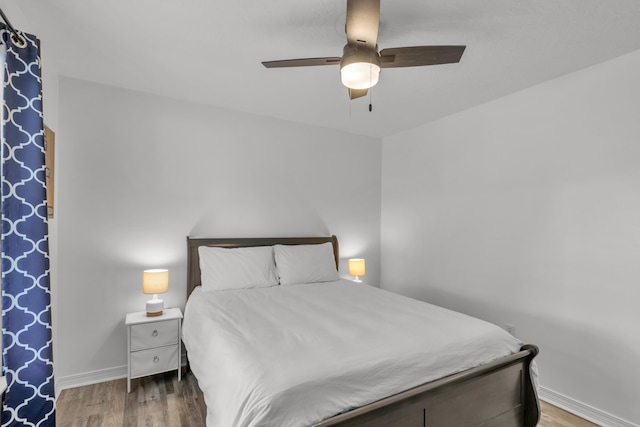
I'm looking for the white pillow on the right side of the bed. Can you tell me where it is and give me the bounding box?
[273,242,340,285]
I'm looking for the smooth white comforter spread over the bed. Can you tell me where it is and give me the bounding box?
[183,280,521,427]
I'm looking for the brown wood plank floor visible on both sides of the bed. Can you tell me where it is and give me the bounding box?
[56,372,597,427]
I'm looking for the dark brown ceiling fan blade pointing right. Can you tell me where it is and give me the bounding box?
[380,46,466,68]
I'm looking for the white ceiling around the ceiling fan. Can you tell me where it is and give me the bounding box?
[9,0,640,137]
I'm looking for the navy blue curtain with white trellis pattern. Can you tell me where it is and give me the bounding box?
[0,24,55,427]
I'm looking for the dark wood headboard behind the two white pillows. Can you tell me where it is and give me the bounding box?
[187,236,340,298]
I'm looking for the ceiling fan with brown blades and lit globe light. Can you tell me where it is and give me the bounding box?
[262,0,466,99]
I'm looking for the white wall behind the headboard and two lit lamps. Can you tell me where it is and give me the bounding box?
[56,78,381,387]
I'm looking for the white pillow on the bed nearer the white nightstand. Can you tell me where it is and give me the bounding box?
[198,246,278,291]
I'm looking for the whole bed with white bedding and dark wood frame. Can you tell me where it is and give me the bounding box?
[183,236,540,427]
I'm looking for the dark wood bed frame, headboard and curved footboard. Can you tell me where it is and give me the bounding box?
[187,236,540,427]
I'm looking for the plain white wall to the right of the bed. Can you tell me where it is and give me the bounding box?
[381,51,640,424]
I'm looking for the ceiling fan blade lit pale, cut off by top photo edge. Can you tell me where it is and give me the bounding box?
[344,0,380,49]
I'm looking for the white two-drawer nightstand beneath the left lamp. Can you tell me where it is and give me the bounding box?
[125,308,182,393]
